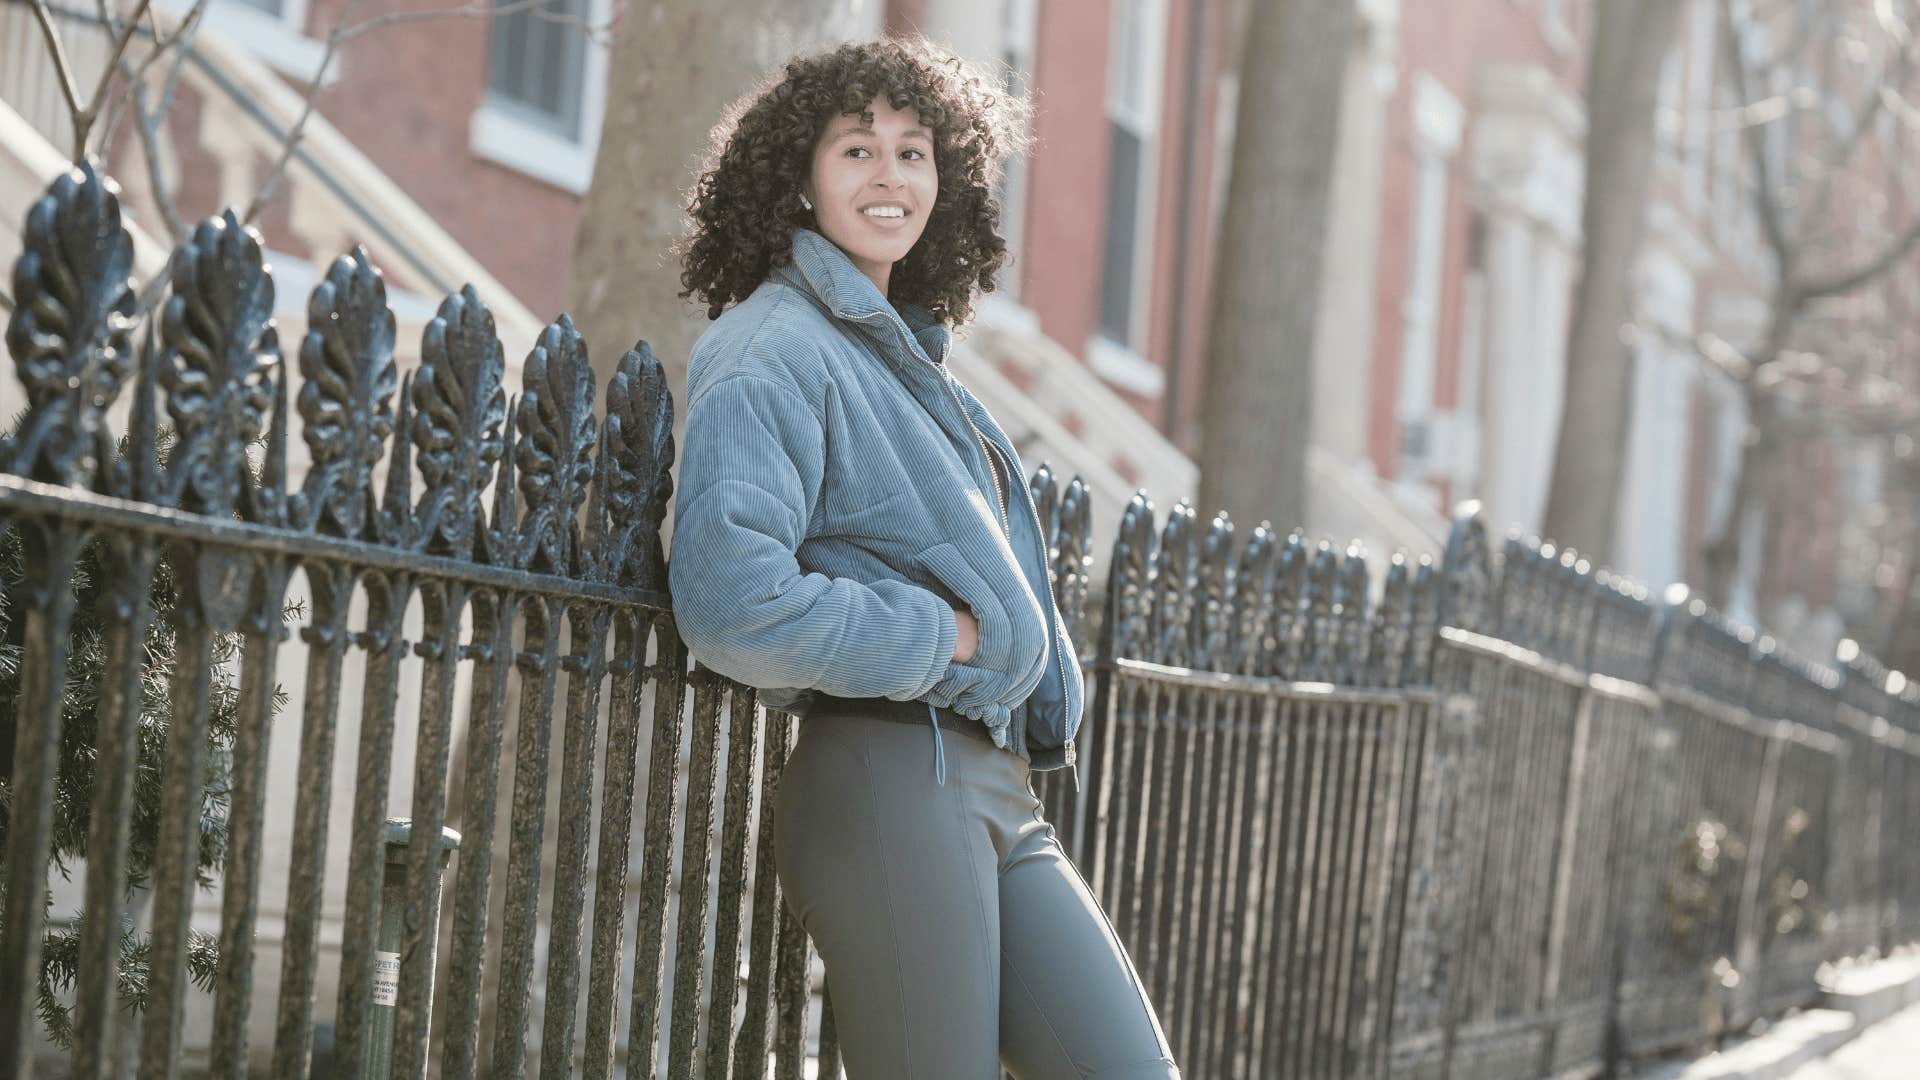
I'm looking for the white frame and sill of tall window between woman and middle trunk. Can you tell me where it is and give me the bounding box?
[1087,0,1167,386]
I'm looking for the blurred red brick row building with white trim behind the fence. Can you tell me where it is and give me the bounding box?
[0,0,1920,730]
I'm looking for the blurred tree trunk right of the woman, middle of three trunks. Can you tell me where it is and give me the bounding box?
[1200,0,1356,528]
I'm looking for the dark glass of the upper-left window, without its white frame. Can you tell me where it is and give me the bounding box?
[483,0,588,138]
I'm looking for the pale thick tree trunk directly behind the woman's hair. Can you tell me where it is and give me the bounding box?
[566,0,879,545]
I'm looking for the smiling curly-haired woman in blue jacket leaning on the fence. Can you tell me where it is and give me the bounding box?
[670,38,1179,1080]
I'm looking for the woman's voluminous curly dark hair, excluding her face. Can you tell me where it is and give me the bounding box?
[676,35,1029,327]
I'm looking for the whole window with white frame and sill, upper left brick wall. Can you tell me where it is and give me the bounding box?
[468,0,612,194]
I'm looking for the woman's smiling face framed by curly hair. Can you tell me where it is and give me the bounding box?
[801,98,941,296]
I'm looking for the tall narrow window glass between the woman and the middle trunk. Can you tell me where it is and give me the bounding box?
[1098,0,1164,346]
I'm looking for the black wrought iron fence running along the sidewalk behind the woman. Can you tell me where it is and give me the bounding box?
[0,165,1920,1078]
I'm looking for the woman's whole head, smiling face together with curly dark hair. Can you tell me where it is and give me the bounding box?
[676,38,1029,327]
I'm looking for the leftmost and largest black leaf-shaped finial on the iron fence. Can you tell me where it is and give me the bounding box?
[0,158,136,484]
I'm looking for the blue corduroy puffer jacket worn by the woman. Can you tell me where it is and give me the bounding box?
[668,229,1083,771]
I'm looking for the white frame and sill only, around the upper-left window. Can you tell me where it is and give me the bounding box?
[467,0,612,194]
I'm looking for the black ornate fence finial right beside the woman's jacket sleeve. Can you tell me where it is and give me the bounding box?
[605,342,674,590]
